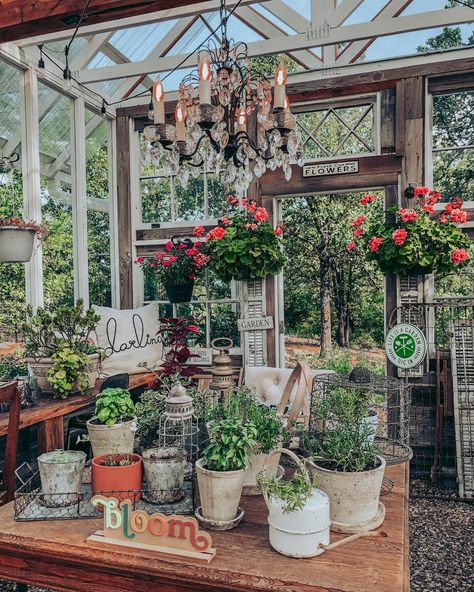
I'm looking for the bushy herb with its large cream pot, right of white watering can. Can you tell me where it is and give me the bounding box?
[301,389,386,533]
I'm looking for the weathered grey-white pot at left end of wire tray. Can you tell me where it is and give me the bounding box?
[38,450,86,508]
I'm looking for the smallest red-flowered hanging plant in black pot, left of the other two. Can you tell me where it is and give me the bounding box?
[135,237,209,303]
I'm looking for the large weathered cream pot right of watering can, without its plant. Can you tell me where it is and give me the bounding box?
[307,456,386,532]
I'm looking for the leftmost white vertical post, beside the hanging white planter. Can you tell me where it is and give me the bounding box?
[21,68,43,309]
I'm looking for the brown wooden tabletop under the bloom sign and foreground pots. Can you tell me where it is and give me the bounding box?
[0,465,409,592]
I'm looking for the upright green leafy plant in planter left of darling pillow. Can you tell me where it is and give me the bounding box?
[22,298,100,359]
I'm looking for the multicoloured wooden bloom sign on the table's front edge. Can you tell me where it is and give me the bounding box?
[87,495,216,563]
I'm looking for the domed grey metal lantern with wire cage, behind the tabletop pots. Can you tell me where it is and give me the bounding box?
[158,384,198,463]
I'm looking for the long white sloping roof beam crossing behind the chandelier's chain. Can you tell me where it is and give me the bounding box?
[79,7,474,83]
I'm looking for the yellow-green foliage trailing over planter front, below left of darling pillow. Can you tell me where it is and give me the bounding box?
[48,342,91,399]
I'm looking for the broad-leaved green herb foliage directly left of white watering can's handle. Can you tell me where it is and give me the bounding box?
[202,419,257,471]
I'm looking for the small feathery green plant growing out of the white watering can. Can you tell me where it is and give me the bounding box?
[257,472,316,512]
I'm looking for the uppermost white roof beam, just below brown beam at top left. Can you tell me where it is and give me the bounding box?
[15,0,266,47]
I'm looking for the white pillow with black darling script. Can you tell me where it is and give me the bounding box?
[93,304,163,376]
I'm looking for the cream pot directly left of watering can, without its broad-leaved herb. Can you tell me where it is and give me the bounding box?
[196,458,245,522]
